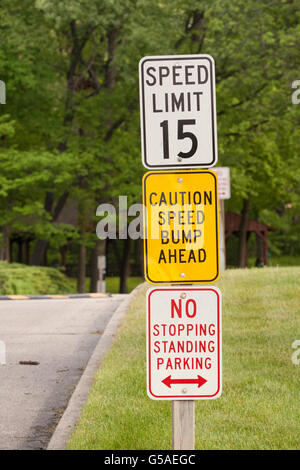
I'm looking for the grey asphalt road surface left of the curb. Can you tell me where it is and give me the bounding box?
[0,295,124,450]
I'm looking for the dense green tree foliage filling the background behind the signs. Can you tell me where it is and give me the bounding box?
[0,0,300,260]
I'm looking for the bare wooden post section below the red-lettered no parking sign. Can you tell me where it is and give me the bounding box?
[172,400,195,450]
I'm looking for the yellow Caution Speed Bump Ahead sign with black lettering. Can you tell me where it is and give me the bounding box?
[143,170,219,284]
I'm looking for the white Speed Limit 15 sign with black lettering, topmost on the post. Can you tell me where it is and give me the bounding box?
[139,54,218,169]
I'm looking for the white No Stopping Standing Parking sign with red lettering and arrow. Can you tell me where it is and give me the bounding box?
[146,286,222,400]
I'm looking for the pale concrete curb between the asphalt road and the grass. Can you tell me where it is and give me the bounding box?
[46,283,144,450]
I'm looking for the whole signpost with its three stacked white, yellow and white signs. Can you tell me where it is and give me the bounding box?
[139,54,222,450]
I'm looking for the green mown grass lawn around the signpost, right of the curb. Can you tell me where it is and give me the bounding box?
[68,267,300,450]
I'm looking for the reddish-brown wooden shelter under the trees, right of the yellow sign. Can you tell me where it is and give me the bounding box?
[225,212,276,265]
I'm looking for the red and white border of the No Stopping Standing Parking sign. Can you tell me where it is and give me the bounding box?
[147,286,222,400]
